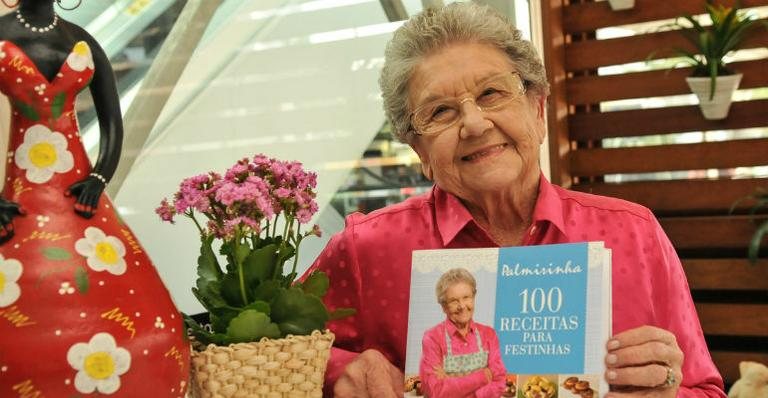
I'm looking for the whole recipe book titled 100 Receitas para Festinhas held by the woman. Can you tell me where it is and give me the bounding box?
[405,242,611,398]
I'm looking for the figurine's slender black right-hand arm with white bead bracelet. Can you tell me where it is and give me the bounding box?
[67,27,123,218]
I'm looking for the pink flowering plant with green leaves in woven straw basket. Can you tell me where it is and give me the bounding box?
[156,155,354,397]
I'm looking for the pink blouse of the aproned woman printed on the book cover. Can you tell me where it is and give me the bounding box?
[419,320,506,398]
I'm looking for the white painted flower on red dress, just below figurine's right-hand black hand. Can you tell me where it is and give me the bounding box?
[75,227,126,275]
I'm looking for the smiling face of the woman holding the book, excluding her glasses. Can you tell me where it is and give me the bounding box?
[408,43,546,199]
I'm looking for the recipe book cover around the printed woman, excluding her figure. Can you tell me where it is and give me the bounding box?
[405,242,611,398]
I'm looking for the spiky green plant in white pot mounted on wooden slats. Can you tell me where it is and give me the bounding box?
[672,0,759,120]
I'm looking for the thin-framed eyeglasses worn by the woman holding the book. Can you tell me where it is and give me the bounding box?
[410,72,526,136]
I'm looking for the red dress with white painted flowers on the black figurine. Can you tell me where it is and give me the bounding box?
[0,41,189,397]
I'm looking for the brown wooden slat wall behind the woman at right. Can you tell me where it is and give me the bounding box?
[542,0,768,385]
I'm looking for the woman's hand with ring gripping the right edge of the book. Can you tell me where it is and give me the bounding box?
[605,326,683,398]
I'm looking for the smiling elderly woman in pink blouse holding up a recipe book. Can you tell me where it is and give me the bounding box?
[304,3,725,398]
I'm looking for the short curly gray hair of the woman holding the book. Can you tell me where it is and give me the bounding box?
[379,3,549,143]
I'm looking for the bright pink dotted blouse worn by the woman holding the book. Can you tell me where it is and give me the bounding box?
[310,176,725,398]
